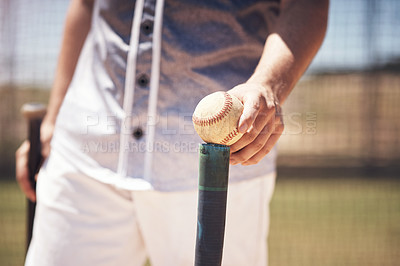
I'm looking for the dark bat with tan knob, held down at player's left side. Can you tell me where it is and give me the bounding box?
[21,103,46,248]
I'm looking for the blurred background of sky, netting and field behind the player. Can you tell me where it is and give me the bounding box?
[0,0,400,266]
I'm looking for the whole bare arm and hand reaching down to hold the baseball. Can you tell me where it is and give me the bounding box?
[225,0,329,165]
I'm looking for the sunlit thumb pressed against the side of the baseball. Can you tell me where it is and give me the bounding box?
[239,94,260,133]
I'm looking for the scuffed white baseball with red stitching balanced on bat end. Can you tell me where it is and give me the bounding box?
[192,91,243,146]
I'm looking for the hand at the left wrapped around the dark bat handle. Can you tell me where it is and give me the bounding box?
[15,121,54,202]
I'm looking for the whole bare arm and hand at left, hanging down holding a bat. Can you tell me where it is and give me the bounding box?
[15,0,94,201]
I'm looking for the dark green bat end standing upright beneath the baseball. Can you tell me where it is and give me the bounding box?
[195,144,230,266]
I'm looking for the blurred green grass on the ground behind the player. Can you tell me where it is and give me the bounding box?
[0,176,400,266]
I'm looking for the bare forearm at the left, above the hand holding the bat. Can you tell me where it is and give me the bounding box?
[44,0,93,124]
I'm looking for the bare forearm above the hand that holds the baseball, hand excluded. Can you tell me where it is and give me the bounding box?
[248,0,329,103]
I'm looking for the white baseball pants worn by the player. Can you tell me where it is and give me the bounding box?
[25,151,275,266]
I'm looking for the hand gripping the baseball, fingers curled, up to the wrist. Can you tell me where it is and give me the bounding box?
[228,83,284,165]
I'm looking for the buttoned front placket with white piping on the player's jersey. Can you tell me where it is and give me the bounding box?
[118,0,163,181]
